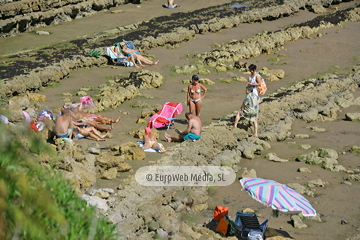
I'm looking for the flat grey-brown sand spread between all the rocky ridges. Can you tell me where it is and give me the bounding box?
[0,0,360,240]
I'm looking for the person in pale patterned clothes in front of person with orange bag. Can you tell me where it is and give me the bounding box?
[234,85,260,137]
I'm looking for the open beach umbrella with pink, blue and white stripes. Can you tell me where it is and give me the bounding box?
[240,178,316,217]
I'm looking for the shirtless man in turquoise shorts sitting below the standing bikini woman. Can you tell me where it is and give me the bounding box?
[165,112,202,142]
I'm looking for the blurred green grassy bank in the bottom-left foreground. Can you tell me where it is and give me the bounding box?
[0,123,116,240]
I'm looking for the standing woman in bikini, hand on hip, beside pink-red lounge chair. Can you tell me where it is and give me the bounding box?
[187,75,207,117]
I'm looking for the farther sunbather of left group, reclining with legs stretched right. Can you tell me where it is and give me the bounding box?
[70,103,114,132]
